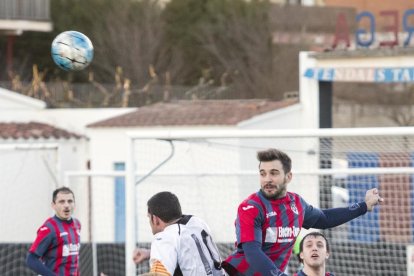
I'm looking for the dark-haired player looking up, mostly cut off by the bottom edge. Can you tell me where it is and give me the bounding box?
[293,232,334,276]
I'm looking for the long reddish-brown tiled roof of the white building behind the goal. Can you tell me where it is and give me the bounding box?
[88,99,298,127]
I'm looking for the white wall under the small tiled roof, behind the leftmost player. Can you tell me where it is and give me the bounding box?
[0,140,85,242]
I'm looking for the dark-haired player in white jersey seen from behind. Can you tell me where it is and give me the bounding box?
[133,192,224,276]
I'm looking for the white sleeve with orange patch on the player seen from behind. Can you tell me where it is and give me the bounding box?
[150,232,178,275]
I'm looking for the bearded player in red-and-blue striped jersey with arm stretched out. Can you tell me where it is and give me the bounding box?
[222,149,383,276]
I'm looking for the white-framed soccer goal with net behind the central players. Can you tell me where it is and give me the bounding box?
[125,127,414,276]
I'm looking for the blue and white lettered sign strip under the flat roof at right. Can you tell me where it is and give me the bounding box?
[304,67,414,83]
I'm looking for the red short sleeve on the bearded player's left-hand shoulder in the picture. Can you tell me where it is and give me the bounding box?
[236,201,263,245]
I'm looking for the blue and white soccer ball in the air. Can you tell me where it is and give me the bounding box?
[51,31,93,71]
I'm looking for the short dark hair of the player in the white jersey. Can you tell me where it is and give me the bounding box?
[147,192,183,222]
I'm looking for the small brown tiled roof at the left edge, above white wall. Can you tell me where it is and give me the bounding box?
[0,122,82,140]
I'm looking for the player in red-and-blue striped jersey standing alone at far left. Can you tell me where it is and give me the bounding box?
[26,187,81,276]
